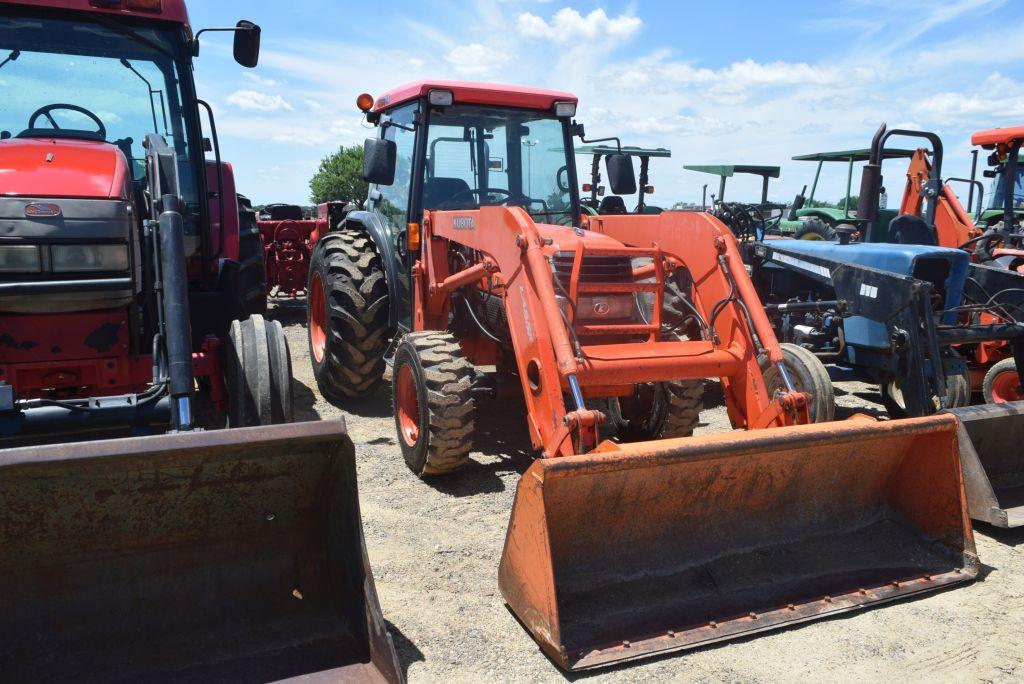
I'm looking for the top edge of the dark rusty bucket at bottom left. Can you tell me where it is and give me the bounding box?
[0,418,347,468]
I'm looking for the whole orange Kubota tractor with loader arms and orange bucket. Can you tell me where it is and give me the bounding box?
[309,81,978,669]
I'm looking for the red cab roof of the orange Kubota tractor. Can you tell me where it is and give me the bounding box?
[374,81,579,112]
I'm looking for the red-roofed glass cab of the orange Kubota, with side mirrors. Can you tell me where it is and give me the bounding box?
[346,81,637,328]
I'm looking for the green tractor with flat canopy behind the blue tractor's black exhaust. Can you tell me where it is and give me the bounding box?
[779,149,913,243]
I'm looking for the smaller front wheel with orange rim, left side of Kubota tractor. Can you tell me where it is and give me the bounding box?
[391,332,475,477]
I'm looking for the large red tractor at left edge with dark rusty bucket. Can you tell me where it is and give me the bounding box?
[0,0,402,682]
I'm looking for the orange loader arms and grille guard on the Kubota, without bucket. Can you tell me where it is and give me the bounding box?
[414,207,808,457]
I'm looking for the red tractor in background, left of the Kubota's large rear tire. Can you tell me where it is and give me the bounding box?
[258,197,348,298]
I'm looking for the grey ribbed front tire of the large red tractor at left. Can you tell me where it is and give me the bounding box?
[224,314,294,427]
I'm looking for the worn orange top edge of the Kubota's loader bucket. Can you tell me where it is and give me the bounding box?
[527,415,958,478]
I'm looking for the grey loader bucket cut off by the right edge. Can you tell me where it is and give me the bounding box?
[948,401,1024,527]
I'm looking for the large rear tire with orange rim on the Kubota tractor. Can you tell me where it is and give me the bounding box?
[306,230,392,402]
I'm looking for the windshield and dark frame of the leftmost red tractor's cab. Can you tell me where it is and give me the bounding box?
[0,6,199,244]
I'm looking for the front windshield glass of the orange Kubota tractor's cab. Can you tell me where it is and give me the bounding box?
[423,105,577,224]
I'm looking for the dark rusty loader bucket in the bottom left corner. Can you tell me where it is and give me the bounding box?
[0,421,402,682]
